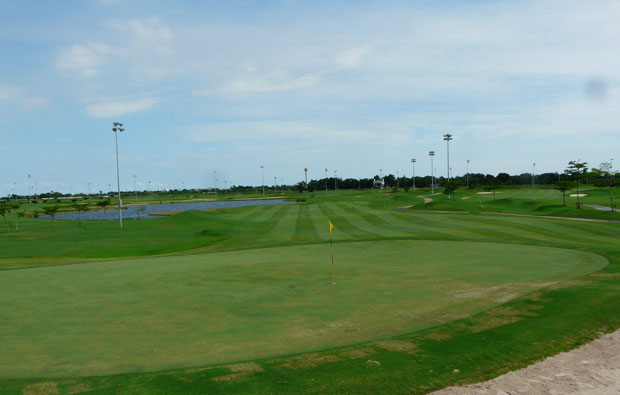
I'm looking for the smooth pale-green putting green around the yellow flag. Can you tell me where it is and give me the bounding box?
[0,240,607,377]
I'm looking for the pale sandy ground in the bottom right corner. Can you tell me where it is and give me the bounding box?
[432,330,620,395]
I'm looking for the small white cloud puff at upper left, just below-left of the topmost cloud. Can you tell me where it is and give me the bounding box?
[55,42,111,78]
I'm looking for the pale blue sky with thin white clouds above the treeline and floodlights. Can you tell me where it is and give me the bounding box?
[0,0,620,196]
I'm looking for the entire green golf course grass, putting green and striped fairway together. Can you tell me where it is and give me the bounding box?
[0,188,620,393]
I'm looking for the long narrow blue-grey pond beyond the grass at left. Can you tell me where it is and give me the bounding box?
[41,199,287,220]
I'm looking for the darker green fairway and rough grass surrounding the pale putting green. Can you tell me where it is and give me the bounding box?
[0,189,620,393]
